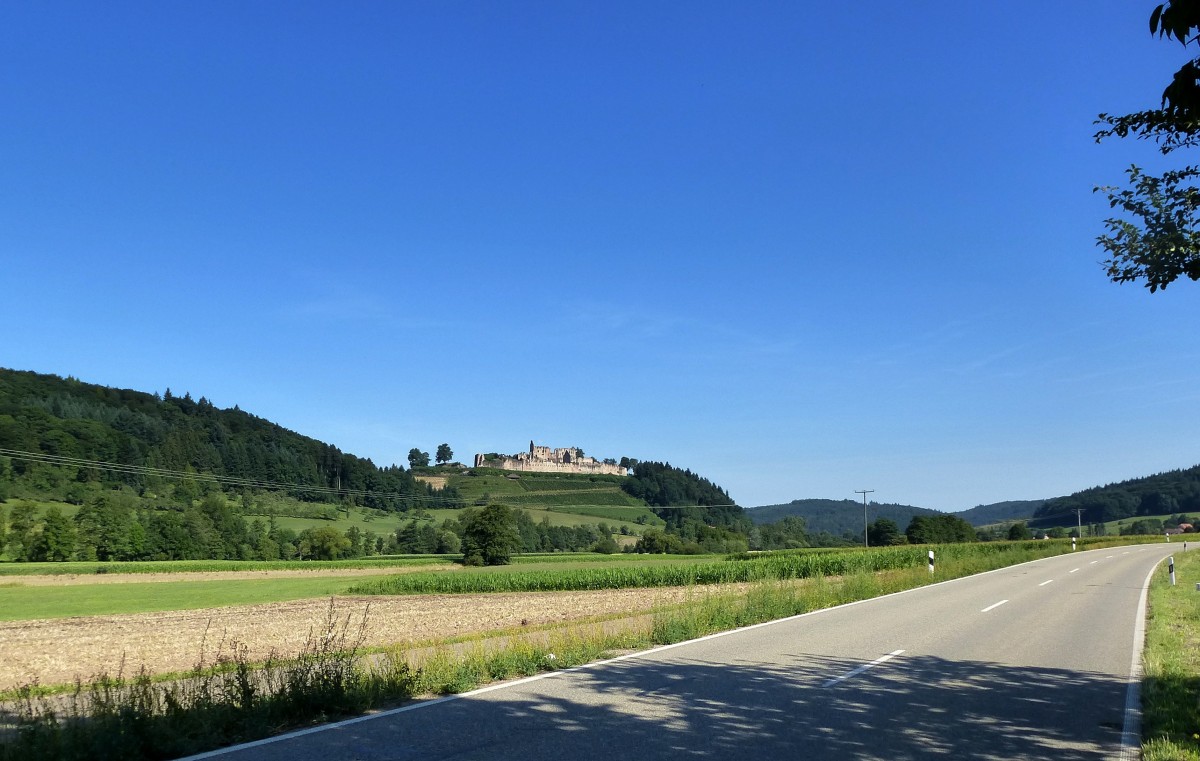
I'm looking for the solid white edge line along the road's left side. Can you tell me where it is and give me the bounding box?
[175,542,1157,761]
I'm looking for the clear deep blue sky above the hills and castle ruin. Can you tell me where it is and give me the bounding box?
[0,0,1200,510]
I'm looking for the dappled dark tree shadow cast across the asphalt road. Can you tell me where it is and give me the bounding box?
[331,654,1126,761]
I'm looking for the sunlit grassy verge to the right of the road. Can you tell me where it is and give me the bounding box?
[1141,545,1200,761]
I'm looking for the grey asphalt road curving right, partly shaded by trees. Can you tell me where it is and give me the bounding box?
[193,544,1182,761]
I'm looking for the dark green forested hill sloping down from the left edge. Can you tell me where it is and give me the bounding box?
[0,368,458,510]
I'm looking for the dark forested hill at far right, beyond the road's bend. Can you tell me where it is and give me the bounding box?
[1033,465,1200,526]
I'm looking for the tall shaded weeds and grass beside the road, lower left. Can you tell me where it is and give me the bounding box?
[0,604,415,761]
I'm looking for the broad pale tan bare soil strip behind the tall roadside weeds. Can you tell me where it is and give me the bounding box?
[0,580,696,689]
